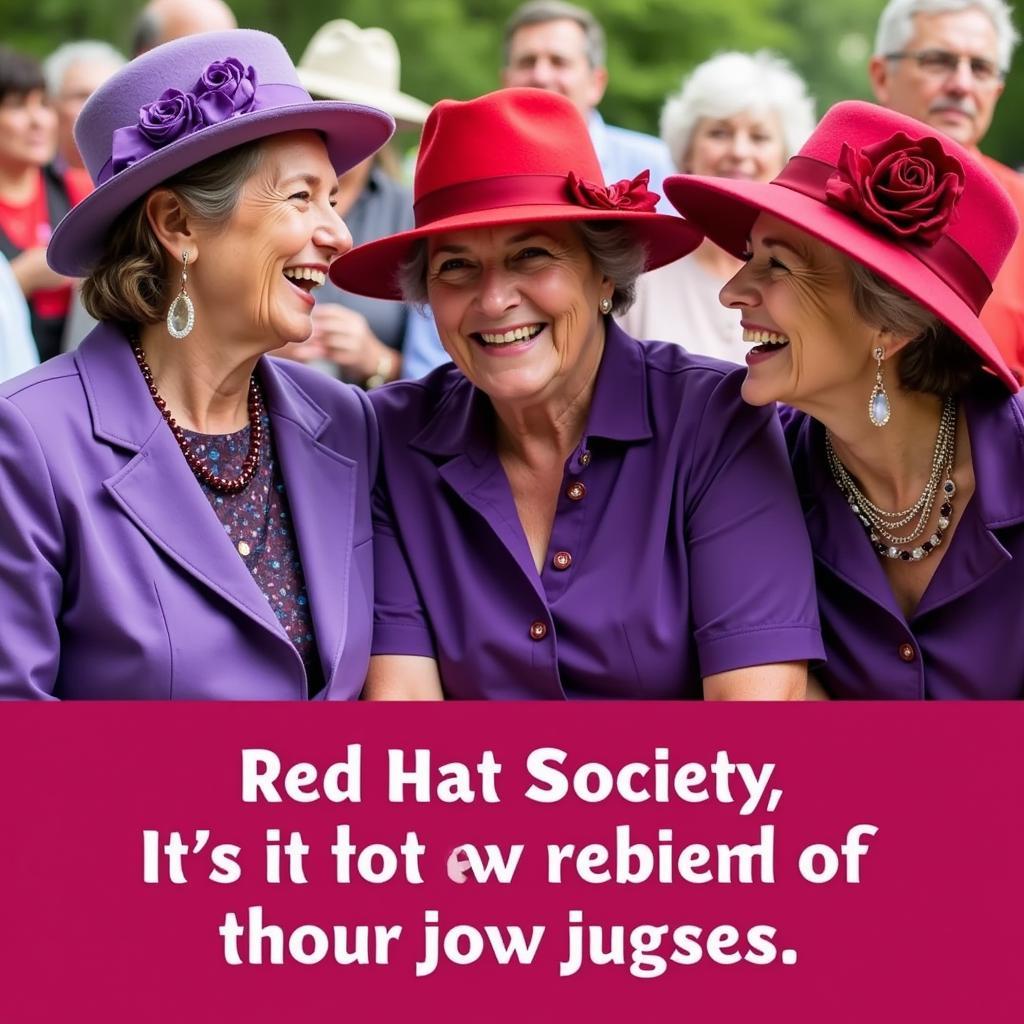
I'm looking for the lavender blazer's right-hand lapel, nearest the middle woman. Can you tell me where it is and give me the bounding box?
[261,359,358,693]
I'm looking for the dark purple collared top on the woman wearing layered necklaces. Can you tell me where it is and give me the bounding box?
[783,385,1024,699]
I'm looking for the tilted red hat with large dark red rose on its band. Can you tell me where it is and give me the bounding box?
[665,101,1019,391]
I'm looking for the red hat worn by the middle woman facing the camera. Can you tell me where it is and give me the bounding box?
[331,89,702,299]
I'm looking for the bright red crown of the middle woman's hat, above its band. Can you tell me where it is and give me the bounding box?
[415,88,604,201]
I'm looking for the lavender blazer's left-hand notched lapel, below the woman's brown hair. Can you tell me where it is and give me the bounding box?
[75,324,298,659]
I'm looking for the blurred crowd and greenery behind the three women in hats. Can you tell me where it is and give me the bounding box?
[0,0,1024,388]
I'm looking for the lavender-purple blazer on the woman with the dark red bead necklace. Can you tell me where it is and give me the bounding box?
[0,325,377,699]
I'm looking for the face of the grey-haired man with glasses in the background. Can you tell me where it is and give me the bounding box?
[870,7,1002,146]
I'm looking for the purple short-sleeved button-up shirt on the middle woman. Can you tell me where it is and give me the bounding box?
[371,319,822,699]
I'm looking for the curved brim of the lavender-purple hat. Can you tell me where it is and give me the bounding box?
[46,100,394,278]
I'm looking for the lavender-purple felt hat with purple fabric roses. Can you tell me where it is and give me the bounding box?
[46,29,394,278]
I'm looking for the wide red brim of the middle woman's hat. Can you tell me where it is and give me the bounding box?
[331,204,703,299]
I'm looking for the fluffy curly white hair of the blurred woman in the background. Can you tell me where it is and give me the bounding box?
[662,50,815,169]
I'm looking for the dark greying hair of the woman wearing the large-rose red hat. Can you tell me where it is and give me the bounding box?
[845,256,983,397]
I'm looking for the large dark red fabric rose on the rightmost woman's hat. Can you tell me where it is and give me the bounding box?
[825,132,964,246]
